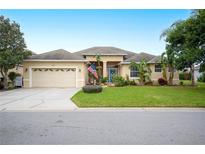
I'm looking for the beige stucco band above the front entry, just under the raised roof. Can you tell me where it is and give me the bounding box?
[86,55,123,62]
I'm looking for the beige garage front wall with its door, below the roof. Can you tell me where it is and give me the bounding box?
[24,62,86,88]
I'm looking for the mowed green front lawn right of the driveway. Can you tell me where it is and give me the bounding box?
[72,81,205,107]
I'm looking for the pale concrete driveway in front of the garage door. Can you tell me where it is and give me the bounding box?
[0,88,79,111]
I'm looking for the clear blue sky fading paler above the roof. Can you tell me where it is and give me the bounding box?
[0,10,191,55]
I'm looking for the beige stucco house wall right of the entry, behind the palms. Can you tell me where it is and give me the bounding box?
[120,64,179,84]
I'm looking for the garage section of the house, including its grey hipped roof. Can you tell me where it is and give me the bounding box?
[23,49,87,88]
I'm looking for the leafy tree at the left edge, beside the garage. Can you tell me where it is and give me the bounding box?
[0,16,31,89]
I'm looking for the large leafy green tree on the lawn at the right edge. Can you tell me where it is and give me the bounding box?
[162,10,205,86]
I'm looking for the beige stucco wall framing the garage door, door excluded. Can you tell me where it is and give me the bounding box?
[23,61,86,88]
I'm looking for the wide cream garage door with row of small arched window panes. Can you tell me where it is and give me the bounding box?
[32,68,76,87]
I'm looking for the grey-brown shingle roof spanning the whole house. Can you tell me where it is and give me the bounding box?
[27,47,160,63]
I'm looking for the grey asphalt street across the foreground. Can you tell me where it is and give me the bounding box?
[0,109,205,144]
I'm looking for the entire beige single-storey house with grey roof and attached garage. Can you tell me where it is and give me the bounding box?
[23,47,179,88]
